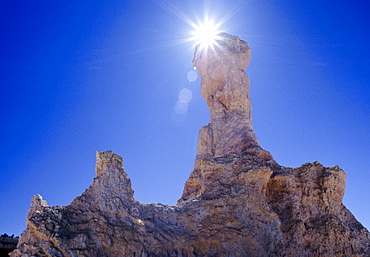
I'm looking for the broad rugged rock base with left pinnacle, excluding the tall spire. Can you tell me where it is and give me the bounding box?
[11,151,370,256]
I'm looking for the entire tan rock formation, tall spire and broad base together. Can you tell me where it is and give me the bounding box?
[11,33,370,257]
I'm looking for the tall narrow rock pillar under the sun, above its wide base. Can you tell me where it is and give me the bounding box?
[193,33,259,160]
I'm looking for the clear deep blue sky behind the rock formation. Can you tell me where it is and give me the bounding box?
[0,0,370,235]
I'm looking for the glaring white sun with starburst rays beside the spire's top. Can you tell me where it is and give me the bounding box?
[191,19,220,49]
